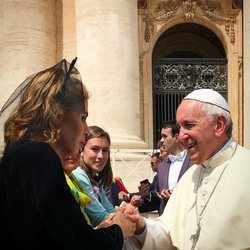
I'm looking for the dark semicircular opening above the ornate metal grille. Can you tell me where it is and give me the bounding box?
[152,23,226,60]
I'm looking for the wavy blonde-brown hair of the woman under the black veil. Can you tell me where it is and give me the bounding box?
[4,67,89,149]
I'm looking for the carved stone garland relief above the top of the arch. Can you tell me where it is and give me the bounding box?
[143,0,238,43]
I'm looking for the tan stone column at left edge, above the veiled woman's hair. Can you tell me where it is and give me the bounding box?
[0,0,56,150]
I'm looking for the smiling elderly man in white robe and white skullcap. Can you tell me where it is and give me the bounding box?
[135,89,250,250]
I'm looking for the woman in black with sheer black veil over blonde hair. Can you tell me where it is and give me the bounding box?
[0,59,135,250]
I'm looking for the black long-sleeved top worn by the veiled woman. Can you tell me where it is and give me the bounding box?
[0,140,123,250]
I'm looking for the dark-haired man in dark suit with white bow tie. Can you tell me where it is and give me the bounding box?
[132,121,192,215]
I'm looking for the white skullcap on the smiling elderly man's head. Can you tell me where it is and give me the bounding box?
[183,89,230,113]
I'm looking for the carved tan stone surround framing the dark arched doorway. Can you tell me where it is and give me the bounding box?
[138,0,243,147]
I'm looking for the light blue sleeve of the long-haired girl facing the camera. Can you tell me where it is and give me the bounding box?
[73,167,114,227]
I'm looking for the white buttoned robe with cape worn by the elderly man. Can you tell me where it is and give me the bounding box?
[138,142,250,250]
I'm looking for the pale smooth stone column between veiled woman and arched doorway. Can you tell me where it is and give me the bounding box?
[76,0,146,148]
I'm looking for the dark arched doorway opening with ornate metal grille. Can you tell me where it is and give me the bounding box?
[152,23,227,147]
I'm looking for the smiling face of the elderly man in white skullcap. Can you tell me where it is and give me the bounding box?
[176,100,219,164]
